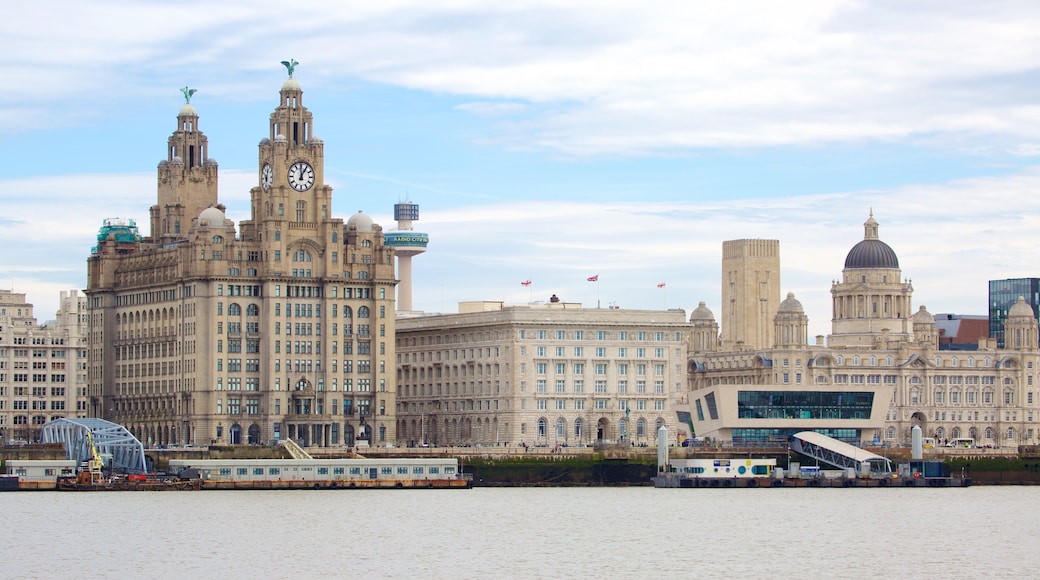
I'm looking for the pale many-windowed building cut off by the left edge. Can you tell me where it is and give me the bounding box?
[0,290,86,445]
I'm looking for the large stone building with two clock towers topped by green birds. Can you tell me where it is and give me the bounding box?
[86,67,396,446]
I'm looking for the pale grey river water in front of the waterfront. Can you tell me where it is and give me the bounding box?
[0,486,1040,579]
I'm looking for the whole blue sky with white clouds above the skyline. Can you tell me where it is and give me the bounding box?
[0,0,1040,335]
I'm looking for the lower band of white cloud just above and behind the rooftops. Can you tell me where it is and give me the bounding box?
[0,166,1040,335]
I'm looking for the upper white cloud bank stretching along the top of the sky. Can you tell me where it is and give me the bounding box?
[6,0,1040,155]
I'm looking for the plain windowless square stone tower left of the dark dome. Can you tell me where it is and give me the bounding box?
[722,240,780,349]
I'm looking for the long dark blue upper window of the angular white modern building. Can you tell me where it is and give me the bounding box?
[736,391,874,419]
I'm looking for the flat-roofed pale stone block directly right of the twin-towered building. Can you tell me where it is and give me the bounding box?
[396,301,688,447]
